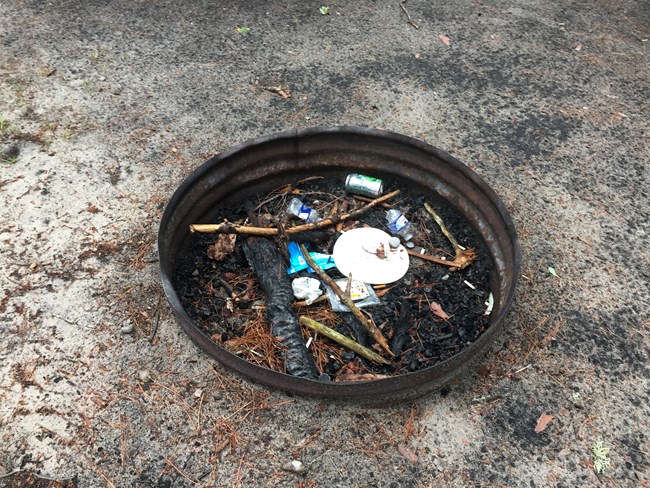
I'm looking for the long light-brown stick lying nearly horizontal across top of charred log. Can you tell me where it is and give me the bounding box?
[190,190,400,236]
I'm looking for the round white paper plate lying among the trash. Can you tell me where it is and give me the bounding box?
[333,227,409,285]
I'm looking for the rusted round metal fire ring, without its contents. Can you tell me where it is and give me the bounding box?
[158,126,521,404]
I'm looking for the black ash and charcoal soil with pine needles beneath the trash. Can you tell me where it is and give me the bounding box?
[174,179,492,381]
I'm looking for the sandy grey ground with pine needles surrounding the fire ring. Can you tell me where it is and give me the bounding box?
[0,0,650,487]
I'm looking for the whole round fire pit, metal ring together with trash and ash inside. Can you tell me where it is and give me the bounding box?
[159,127,520,403]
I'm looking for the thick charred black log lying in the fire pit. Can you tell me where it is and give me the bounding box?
[243,237,319,379]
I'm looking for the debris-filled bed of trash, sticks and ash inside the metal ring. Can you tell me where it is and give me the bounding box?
[174,175,493,381]
